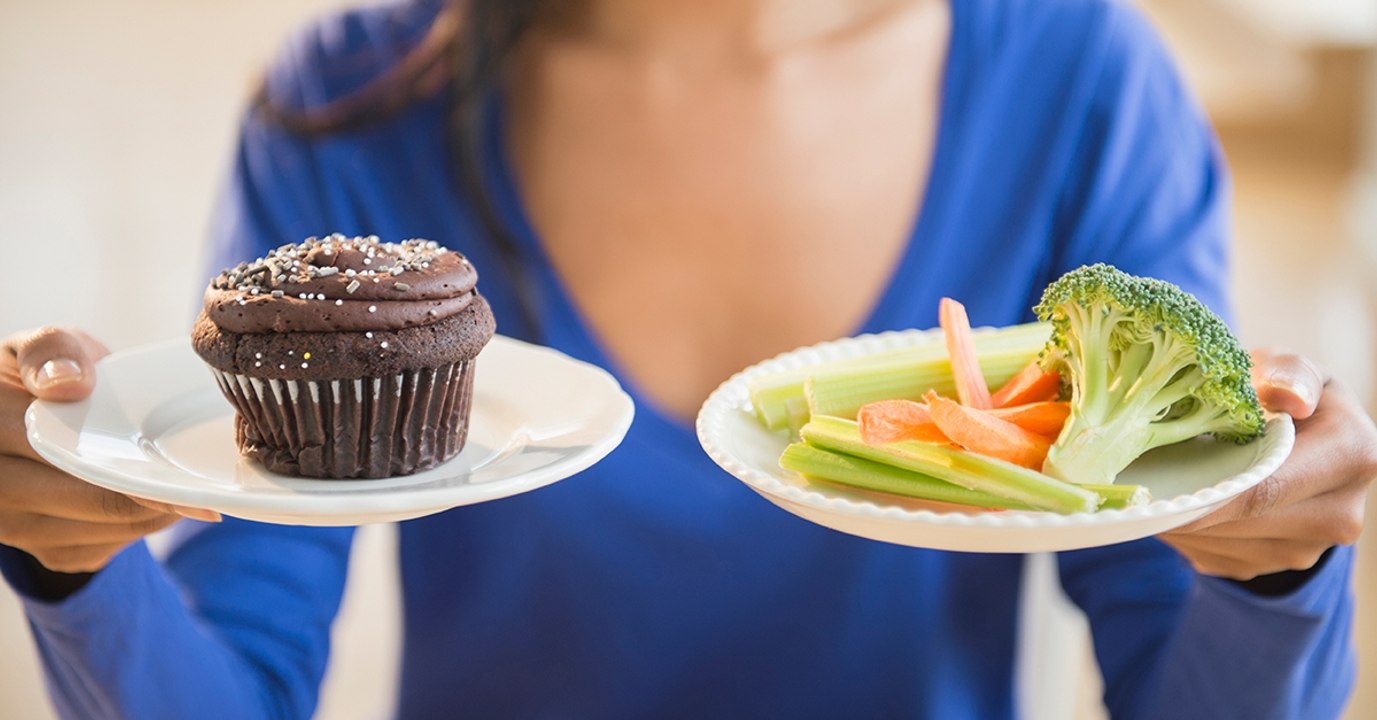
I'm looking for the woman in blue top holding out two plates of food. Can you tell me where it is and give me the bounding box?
[0,0,1377,719]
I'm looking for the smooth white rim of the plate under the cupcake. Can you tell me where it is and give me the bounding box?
[25,335,635,525]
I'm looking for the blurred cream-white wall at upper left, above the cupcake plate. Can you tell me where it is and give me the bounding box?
[0,0,355,347]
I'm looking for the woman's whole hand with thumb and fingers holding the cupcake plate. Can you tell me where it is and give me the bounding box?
[0,328,220,573]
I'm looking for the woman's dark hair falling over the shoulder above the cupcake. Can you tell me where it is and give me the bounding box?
[253,0,544,339]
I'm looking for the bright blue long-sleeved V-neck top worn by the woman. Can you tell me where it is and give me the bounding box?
[0,0,1354,720]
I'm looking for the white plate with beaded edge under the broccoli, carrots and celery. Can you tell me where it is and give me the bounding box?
[698,329,1296,552]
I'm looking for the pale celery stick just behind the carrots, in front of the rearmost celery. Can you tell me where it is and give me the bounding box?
[804,346,1042,419]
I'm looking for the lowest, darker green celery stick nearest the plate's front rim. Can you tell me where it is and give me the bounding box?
[779,442,1033,509]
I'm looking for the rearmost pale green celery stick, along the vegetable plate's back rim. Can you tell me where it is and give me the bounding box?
[750,322,1052,430]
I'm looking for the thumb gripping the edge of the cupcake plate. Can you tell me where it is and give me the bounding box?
[7,328,110,402]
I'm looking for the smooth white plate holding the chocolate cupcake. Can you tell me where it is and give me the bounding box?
[25,336,633,525]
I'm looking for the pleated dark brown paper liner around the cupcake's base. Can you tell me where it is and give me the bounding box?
[211,361,474,479]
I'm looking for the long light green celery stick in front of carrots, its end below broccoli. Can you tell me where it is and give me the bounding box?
[801,416,1100,513]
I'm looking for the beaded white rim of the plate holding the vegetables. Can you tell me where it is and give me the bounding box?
[694,326,1296,529]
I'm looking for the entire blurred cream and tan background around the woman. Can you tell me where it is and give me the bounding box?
[0,0,1377,720]
